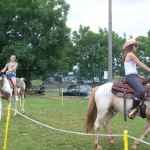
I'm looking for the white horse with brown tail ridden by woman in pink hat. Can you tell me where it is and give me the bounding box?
[85,82,150,150]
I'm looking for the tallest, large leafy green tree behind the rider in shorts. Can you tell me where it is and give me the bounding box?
[0,0,70,86]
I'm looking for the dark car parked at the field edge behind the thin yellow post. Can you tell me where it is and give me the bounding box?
[60,84,92,96]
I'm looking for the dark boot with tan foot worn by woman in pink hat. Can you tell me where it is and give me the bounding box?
[128,99,140,119]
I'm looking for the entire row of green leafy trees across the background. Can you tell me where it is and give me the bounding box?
[0,0,150,86]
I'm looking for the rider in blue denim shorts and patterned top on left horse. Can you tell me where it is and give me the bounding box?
[1,54,19,101]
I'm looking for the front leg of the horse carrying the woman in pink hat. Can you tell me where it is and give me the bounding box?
[131,119,150,150]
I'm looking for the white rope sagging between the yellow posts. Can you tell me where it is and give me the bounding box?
[4,108,150,145]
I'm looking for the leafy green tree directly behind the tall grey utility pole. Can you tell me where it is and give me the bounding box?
[72,25,125,81]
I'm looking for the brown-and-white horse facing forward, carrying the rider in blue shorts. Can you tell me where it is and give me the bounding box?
[0,73,26,121]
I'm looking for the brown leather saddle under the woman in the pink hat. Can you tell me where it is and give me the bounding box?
[111,77,150,121]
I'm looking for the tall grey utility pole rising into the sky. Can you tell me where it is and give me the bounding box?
[108,0,112,82]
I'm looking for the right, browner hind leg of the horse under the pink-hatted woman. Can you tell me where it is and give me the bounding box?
[103,109,116,146]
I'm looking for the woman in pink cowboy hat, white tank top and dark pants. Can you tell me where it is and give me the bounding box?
[122,39,150,119]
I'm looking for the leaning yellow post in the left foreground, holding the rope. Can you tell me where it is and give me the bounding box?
[4,104,11,150]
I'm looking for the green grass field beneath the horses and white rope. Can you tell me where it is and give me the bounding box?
[0,92,150,150]
